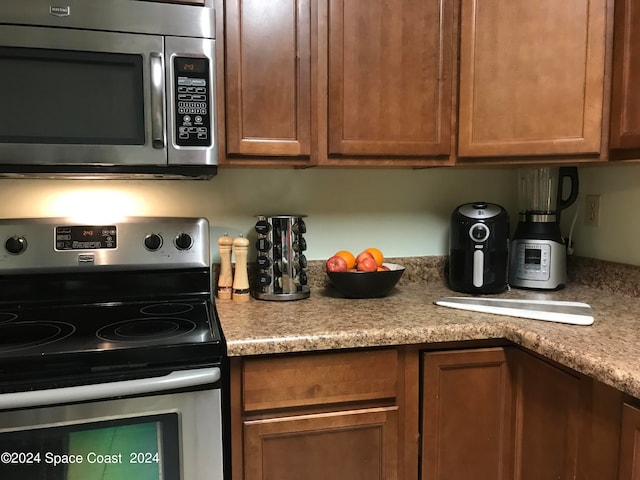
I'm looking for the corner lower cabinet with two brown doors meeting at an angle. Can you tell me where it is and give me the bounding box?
[420,347,624,480]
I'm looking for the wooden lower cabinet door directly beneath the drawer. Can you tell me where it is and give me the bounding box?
[244,407,398,480]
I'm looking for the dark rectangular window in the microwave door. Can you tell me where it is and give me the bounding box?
[0,47,145,145]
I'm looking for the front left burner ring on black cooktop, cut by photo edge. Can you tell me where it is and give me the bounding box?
[0,322,76,353]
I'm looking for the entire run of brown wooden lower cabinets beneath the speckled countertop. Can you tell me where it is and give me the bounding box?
[231,343,640,480]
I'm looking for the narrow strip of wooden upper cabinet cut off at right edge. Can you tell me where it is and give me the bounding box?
[610,0,640,158]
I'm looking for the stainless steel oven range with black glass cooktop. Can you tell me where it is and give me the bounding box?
[0,217,229,480]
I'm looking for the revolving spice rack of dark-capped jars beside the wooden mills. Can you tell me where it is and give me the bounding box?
[251,215,310,300]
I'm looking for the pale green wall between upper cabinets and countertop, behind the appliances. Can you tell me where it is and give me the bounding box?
[0,166,640,265]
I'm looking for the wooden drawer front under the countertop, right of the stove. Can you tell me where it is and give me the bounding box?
[242,350,398,411]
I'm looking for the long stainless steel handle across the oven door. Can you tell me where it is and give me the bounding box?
[0,367,221,410]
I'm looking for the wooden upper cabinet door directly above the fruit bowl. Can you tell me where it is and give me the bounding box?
[328,0,457,163]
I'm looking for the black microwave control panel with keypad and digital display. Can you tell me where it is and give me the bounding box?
[173,57,213,147]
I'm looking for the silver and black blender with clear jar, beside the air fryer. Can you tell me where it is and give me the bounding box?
[509,167,578,290]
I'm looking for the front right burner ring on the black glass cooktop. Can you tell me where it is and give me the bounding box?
[96,317,196,342]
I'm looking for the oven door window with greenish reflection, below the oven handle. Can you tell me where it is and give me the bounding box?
[0,413,180,480]
